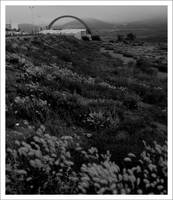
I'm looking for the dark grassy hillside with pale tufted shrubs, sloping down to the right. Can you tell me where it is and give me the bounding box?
[6,36,167,194]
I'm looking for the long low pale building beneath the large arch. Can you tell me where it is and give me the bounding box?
[39,29,90,40]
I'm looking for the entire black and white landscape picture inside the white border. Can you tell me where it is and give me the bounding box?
[1,2,172,199]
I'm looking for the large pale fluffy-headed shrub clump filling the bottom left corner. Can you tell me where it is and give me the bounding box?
[6,126,75,194]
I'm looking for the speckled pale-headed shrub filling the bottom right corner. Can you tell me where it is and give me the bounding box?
[140,142,167,194]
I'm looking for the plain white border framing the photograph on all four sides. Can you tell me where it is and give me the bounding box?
[0,0,173,200]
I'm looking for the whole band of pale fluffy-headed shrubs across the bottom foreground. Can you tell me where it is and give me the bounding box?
[6,125,167,194]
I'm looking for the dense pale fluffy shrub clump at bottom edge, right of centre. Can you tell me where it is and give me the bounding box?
[78,152,122,194]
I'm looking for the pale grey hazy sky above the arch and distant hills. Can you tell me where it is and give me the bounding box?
[6,6,167,27]
